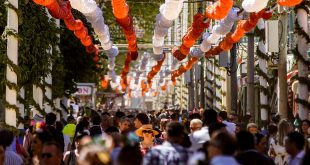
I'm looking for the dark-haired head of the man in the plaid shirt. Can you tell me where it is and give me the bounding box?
[166,121,184,144]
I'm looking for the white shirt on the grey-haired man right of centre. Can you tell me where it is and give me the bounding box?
[189,126,210,151]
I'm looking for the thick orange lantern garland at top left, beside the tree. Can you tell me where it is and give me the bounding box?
[33,0,99,61]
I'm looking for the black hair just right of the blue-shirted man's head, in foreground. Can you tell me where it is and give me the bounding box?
[236,131,255,151]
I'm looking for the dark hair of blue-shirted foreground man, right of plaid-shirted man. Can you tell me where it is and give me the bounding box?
[210,132,237,155]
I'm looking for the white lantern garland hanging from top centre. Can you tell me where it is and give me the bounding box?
[152,0,185,56]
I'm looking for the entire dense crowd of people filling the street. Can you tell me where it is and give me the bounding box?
[0,109,310,165]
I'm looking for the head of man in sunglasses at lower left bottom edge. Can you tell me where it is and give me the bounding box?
[40,142,62,165]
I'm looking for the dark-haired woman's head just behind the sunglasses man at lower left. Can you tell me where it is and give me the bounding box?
[31,130,53,156]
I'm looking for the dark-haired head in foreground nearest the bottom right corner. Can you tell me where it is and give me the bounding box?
[285,131,305,157]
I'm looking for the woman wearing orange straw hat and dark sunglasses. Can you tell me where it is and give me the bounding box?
[136,124,158,156]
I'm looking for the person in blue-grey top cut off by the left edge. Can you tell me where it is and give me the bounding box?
[0,129,23,165]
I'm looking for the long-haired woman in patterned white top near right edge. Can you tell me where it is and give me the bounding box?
[268,119,293,165]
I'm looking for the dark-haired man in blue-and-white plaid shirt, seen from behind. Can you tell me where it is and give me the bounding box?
[143,122,190,165]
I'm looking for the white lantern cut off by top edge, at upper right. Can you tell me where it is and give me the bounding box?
[242,0,269,13]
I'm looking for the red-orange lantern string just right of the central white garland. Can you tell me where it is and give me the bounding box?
[172,12,210,61]
